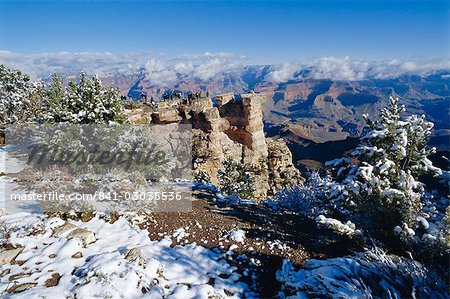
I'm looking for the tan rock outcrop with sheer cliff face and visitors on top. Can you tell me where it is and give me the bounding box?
[125,92,303,199]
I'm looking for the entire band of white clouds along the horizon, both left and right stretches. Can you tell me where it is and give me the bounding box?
[0,51,450,86]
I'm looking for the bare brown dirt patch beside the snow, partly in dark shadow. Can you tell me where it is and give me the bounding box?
[142,190,357,297]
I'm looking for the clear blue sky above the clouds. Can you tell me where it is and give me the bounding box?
[0,1,450,63]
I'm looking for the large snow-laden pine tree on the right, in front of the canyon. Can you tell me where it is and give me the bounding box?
[327,98,441,233]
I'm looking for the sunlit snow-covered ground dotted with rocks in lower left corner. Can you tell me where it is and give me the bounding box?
[0,213,248,298]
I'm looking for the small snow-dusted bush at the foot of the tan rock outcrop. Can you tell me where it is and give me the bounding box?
[217,159,255,199]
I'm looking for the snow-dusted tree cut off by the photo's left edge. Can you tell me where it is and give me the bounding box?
[0,64,43,126]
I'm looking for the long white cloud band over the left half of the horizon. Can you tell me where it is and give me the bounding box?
[0,51,245,85]
